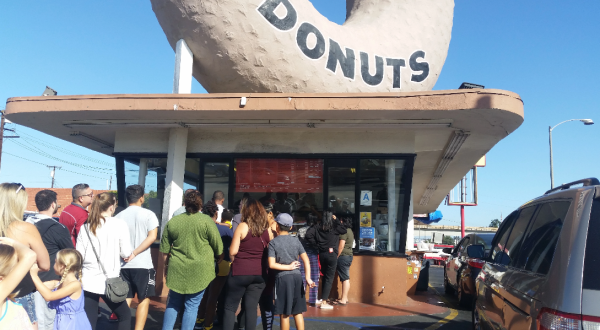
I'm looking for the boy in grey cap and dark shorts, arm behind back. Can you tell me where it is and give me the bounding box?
[269,213,315,330]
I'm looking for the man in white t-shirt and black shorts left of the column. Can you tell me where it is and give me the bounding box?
[116,184,158,330]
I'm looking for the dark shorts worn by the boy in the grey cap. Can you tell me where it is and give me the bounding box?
[273,274,306,315]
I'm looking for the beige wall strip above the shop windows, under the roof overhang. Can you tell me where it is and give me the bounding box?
[115,128,415,154]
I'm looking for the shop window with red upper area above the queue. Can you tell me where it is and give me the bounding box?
[234,158,324,230]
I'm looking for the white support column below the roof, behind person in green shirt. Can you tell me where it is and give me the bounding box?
[160,128,188,235]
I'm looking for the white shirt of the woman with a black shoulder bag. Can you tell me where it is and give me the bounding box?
[77,217,133,294]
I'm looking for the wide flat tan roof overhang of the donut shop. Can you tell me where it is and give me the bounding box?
[5,89,524,213]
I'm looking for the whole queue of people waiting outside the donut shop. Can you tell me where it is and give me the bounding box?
[0,183,354,330]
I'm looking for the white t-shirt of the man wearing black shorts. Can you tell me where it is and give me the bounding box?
[115,205,158,269]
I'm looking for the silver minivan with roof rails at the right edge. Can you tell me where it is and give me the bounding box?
[473,178,600,330]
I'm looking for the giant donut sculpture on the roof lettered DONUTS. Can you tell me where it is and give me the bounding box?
[151,0,454,93]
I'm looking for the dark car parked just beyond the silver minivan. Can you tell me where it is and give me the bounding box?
[442,233,494,307]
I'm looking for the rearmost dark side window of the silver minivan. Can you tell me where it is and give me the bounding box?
[514,201,571,275]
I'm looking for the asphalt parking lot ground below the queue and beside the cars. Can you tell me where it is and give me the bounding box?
[97,266,471,330]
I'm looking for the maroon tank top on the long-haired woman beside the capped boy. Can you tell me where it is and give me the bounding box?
[231,229,270,276]
